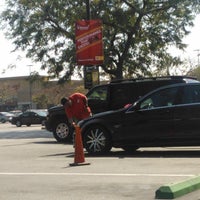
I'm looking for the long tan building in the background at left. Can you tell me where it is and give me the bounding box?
[0,76,86,111]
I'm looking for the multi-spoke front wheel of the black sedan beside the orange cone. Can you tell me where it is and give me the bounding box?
[83,125,112,155]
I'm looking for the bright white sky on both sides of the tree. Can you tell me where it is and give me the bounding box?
[0,0,200,78]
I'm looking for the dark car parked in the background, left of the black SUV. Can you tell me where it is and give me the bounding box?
[11,110,46,127]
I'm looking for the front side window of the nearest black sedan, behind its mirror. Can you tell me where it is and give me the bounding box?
[140,88,178,109]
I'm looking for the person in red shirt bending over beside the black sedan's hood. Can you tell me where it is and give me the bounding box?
[61,93,92,124]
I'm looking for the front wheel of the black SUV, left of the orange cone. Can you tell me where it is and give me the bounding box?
[53,121,71,143]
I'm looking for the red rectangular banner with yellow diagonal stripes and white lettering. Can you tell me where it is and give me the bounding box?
[76,20,104,65]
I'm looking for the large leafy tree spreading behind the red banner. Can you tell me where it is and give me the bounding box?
[0,0,200,81]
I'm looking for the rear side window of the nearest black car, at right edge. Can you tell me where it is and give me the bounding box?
[182,85,200,104]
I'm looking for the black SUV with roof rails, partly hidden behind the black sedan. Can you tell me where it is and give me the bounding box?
[45,76,196,142]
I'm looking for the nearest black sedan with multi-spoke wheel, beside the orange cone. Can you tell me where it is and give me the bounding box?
[78,82,200,154]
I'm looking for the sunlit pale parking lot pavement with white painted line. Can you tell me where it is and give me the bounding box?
[0,123,200,200]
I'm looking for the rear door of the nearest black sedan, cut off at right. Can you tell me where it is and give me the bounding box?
[173,84,200,144]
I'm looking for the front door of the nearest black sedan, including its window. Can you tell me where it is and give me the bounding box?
[117,88,177,145]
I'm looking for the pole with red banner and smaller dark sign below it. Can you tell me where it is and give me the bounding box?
[76,0,104,89]
